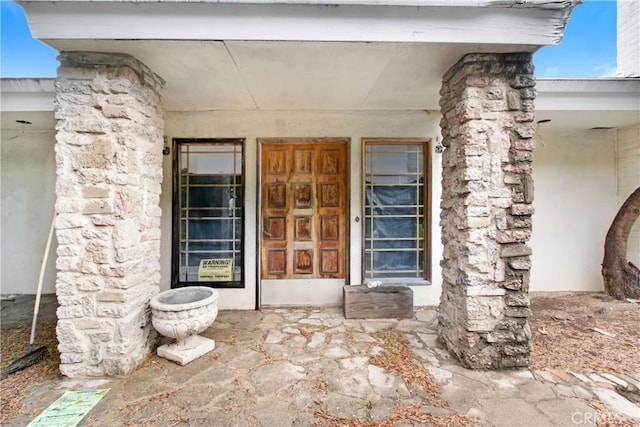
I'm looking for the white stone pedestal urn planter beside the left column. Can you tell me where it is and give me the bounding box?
[150,286,218,366]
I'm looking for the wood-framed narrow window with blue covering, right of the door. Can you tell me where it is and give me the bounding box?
[364,139,430,282]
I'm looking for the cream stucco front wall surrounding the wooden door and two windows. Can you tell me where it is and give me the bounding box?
[161,111,442,309]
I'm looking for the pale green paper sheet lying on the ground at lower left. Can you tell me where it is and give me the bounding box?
[28,388,110,427]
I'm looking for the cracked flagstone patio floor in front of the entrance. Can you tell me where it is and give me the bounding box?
[0,298,640,427]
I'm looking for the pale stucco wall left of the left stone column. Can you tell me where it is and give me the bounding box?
[0,130,56,295]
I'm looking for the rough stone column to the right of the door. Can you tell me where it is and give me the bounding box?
[439,53,536,369]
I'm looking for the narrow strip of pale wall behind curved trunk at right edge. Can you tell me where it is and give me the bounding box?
[616,125,640,266]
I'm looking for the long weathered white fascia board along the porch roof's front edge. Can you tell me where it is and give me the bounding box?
[21,1,575,45]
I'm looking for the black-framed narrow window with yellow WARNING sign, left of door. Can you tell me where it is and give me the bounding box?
[172,140,244,288]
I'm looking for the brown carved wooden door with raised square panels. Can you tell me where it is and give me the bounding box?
[260,138,349,290]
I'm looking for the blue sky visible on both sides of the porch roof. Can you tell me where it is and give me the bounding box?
[0,0,616,77]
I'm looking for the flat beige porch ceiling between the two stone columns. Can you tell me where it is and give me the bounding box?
[47,40,532,111]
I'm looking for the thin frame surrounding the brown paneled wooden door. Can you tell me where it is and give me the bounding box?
[256,137,351,308]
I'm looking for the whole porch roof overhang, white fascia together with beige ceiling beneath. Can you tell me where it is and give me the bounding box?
[12,0,592,111]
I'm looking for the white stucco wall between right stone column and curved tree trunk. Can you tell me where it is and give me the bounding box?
[530,130,617,291]
